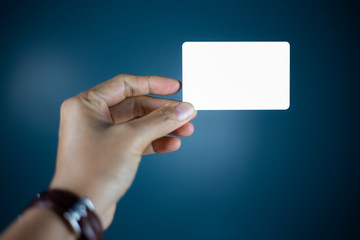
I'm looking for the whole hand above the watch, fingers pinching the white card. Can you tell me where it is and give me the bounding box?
[50,74,196,228]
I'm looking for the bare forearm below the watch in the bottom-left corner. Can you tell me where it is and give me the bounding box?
[0,207,75,240]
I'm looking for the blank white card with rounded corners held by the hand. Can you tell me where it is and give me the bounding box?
[182,42,290,110]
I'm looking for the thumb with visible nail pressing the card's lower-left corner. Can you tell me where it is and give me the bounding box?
[129,102,196,148]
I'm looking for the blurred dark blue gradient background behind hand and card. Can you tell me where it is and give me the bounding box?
[0,0,360,240]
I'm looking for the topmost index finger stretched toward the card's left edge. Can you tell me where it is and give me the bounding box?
[90,74,181,107]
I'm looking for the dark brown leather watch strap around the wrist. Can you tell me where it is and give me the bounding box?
[28,189,103,240]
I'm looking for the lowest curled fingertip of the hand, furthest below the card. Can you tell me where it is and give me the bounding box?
[143,137,181,155]
